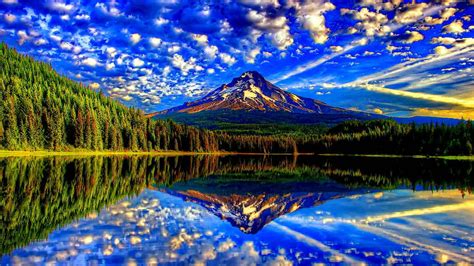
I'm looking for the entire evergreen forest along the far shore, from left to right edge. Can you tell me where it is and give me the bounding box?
[0,43,474,156]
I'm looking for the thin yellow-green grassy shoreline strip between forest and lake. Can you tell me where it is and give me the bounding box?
[0,150,474,160]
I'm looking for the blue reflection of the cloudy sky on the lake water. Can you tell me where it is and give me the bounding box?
[1,189,474,265]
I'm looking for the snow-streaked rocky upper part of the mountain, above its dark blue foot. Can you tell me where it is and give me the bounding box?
[158,71,346,114]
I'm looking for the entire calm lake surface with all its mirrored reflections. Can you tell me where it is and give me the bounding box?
[0,156,474,265]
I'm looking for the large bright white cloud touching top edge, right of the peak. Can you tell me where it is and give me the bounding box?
[290,1,336,44]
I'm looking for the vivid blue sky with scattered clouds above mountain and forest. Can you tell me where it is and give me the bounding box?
[0,0,474,118]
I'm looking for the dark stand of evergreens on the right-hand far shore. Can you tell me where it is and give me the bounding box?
[297,120,474,155]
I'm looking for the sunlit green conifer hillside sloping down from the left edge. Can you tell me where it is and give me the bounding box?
[0,43,218,151]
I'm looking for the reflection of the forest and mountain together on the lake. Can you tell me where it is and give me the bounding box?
[0,156,474,254]
